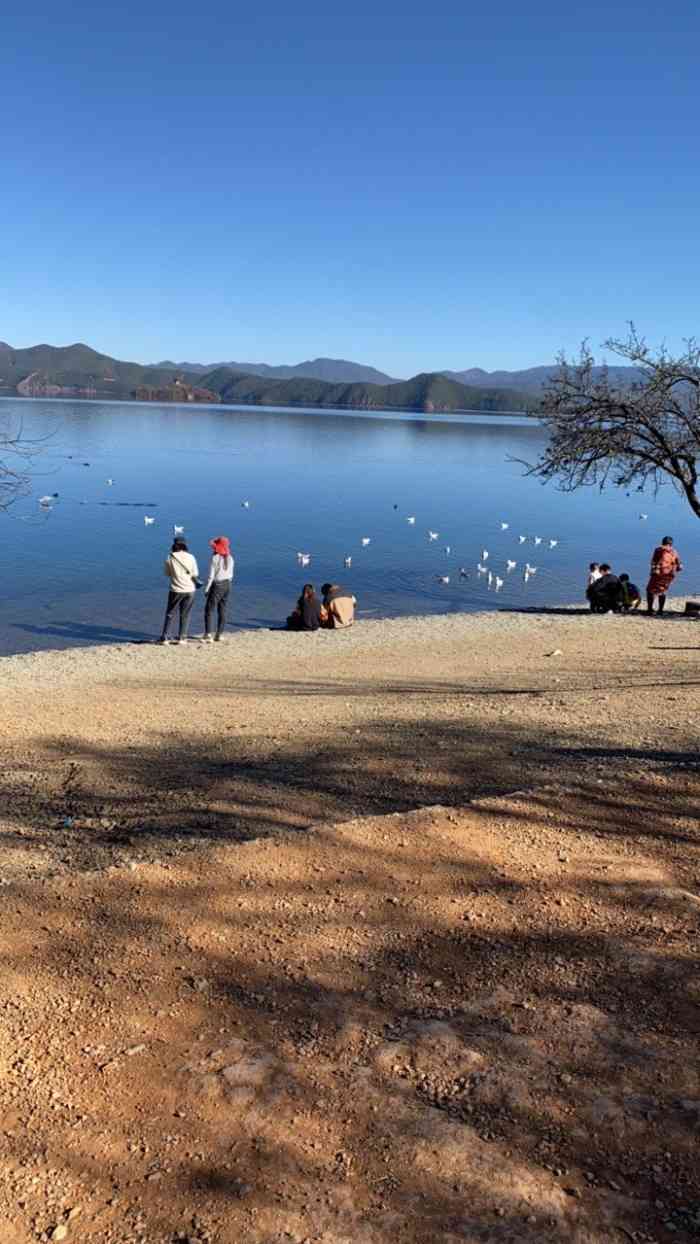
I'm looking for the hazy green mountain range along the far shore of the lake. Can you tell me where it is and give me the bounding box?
[0,342,637,412]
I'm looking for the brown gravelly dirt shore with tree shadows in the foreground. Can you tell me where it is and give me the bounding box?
[0,615,700,1244]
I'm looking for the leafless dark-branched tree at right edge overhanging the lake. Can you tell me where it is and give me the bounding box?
[526,325,700,518]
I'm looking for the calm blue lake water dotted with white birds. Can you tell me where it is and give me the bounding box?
[0,399,700,654]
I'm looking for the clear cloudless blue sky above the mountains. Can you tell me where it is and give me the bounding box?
[0,0,700,376]
